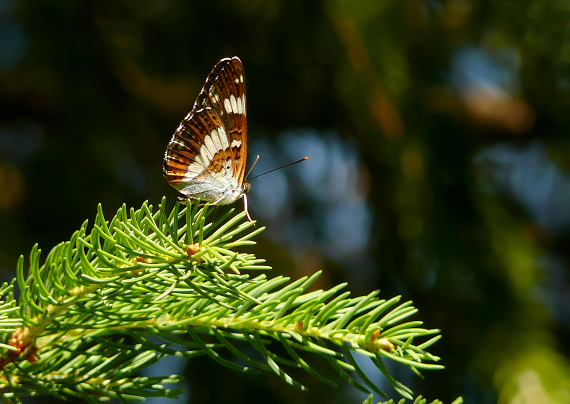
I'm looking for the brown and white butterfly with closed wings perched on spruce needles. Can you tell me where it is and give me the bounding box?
[162,57,251,221]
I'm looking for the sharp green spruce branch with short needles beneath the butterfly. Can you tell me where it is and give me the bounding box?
[0,199,441,402]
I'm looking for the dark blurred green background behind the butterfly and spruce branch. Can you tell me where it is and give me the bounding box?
[0,0,570,403]
